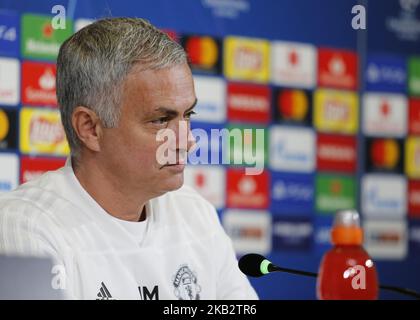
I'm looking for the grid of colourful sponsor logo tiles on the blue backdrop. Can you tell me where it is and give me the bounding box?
[0,13,420,259]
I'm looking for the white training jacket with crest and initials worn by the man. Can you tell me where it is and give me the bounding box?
[0,161,258,300]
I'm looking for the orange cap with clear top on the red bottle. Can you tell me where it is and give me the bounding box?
[331,209,363,245]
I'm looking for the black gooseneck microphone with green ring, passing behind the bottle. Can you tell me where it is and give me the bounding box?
[238,253,420,299]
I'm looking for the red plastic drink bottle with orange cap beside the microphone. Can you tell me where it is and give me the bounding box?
[317,210,379,300]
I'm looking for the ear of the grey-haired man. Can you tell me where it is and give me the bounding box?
[71,106,102,152]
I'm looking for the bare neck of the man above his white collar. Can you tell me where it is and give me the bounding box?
[73,156,149,222]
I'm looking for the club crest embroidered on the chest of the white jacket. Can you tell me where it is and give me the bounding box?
[173,265,201,300]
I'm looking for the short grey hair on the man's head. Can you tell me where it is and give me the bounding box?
[56,18,188,159]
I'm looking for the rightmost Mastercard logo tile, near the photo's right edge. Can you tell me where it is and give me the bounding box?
[370,139,400,169]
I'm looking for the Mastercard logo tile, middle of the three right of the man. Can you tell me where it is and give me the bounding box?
[277,90,309,121]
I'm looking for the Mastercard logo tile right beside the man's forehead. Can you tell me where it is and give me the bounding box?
[185,37,219,69]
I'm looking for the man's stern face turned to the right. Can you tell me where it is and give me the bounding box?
[98,64,196,197]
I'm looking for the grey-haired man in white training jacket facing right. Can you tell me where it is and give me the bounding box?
[0,18,257,300]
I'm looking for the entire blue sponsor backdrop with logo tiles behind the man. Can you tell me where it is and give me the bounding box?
[0,0,420,299]
